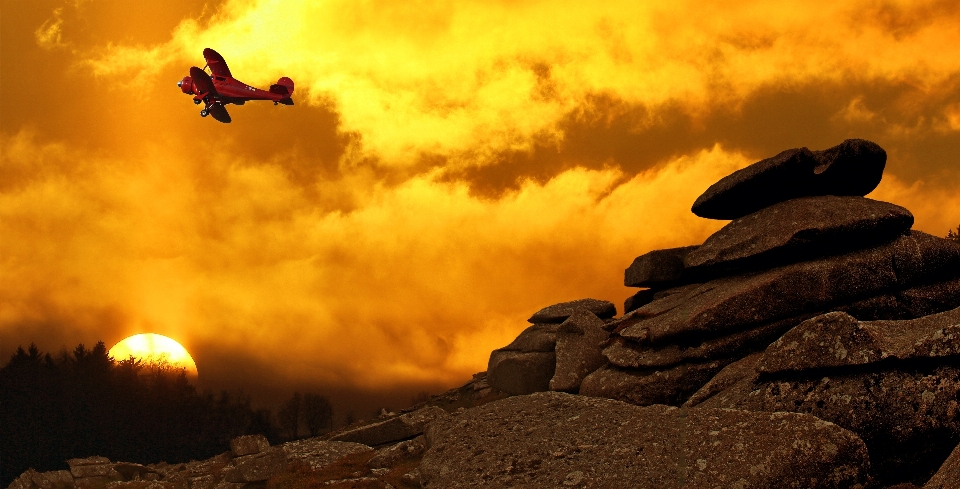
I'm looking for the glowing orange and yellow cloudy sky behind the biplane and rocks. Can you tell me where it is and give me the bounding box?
[0,0,960,407]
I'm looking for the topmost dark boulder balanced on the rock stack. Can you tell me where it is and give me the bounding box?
[692,139,887,219]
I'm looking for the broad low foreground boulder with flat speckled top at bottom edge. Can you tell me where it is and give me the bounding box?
[420,393,869,489]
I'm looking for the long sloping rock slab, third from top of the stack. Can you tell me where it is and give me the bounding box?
[619,231,960,344]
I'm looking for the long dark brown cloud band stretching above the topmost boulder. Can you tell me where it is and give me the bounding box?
[445,77,960,198]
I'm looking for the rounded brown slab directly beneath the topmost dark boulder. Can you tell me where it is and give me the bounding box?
[683,195,913,271]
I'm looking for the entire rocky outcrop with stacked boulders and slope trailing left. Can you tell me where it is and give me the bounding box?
[11,140,960,489]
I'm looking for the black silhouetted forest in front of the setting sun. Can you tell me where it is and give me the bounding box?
[0,341,333,487]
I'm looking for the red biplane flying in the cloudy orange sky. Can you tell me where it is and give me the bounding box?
[177,48,293,122]
